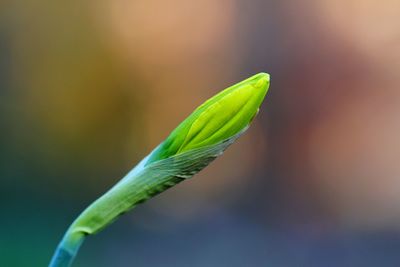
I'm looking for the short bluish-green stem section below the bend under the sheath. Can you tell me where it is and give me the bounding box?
[49,231,86,267]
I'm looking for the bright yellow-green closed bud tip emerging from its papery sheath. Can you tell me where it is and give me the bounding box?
[148,73,269,162]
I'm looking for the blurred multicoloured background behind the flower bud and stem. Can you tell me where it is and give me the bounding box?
[0,0,400,267]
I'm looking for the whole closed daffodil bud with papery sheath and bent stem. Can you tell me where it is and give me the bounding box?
[50,73,269,267]
